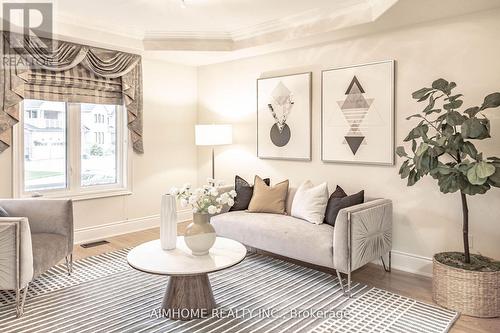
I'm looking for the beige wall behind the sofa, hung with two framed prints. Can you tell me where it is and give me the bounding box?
[198,10,500,273]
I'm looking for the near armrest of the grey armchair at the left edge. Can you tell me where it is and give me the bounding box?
[0,217,33,290]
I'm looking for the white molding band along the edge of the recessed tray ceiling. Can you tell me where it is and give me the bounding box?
[50,0,399,52]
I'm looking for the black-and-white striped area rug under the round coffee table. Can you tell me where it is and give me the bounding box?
[0,250,457,333]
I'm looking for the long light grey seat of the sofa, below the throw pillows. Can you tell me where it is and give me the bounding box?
[211,211,333,268]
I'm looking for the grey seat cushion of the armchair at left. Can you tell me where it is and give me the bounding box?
[31,233,68,277]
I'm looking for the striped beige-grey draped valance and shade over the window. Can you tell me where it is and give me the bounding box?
[0,31,144,153]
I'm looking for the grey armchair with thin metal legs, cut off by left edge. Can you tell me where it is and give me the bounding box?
[0,199,73,317]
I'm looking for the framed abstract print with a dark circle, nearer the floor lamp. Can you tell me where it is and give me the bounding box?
[257,72,311,160]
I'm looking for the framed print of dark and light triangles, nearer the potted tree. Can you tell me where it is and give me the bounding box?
[321,60,394,165]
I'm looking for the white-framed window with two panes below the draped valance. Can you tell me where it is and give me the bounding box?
[15,100,129,198]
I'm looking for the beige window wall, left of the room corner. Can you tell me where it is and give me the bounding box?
[0,57,197,240]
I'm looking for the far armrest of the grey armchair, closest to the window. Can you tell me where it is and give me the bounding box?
[0,199,74,252]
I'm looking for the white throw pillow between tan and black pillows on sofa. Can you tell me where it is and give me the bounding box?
[291,180,328,224]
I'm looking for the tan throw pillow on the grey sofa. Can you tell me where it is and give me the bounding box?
[248,176,288,214]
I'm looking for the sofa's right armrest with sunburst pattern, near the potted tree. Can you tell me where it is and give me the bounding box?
[333,199,392,273]
